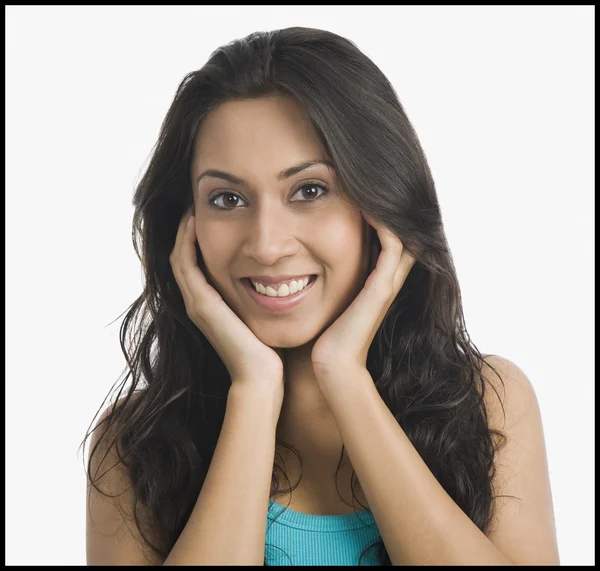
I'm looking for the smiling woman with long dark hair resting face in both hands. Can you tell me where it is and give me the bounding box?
[86,28,559,565]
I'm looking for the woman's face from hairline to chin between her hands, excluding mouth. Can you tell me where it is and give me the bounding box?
[191,97,372,348]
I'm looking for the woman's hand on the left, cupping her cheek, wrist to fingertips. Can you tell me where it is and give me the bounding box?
[169,212,284,394]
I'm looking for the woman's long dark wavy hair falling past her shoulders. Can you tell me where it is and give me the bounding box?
[79,27,506,565]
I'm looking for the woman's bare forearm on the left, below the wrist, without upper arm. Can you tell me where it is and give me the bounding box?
[164,383,281,565]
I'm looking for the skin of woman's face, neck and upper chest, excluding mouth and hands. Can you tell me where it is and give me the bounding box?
[190,97,377,500]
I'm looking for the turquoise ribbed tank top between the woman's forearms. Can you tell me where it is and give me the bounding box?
[265,500,380,566]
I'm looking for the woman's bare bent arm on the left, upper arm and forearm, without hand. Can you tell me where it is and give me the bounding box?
[87,383,282,565]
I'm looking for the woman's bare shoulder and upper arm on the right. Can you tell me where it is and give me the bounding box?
[482,355,560,565]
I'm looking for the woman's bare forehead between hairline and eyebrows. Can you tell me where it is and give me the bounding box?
[194,96,325,172]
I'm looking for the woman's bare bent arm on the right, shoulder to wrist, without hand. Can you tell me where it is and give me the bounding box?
[321,365,559,565]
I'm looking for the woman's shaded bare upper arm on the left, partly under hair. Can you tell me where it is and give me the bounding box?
[86,399,162,565]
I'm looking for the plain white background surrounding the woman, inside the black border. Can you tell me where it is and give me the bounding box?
[6,6,595,565]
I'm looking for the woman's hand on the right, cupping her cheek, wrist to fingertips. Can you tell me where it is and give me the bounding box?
[311,213,416,380]
